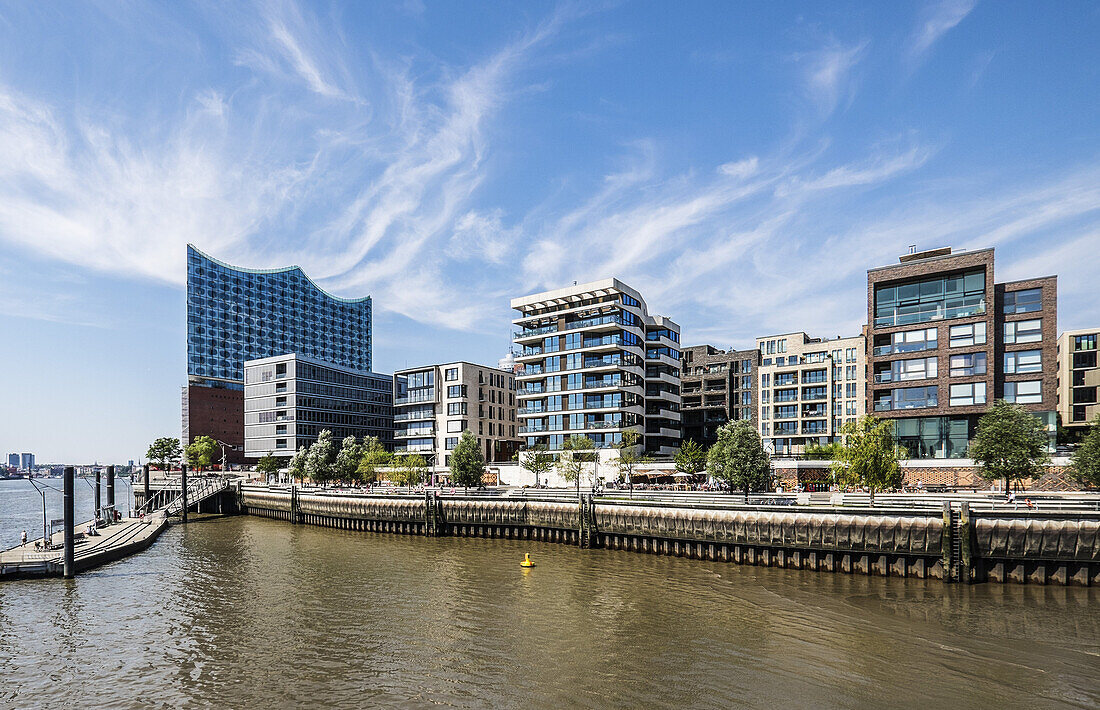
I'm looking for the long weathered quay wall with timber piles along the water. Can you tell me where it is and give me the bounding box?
[239,485,1100,586]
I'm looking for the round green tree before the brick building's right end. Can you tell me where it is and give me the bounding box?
[968,400,1051,495]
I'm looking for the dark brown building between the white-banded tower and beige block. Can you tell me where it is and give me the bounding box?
[680,346,760,447]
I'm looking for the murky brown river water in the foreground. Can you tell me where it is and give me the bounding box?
[0,482,1100,709]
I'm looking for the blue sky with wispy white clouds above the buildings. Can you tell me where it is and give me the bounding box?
[0,0,1100,461]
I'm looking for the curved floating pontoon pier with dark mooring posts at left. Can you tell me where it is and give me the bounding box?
[0,512,168,580]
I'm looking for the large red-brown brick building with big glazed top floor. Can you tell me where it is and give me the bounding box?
[867,248,1058,458]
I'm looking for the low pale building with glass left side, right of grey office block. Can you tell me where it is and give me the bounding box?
[393,362,519,478]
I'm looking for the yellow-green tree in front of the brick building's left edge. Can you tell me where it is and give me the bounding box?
[832,416,904,505]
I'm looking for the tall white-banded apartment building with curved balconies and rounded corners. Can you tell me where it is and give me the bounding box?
[512,278,681,456]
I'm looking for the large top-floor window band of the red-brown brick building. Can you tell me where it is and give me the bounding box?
[875,271,986,326]
